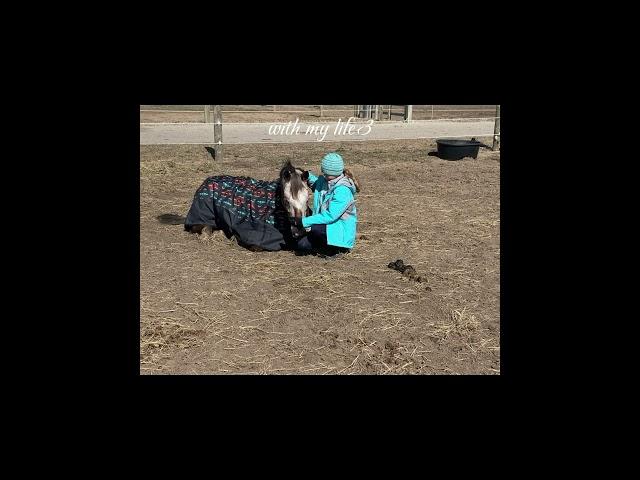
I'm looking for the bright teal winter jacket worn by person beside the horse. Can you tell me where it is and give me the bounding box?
[302,172,358,249]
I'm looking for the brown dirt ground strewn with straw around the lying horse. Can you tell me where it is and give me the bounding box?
[140,138,500,375]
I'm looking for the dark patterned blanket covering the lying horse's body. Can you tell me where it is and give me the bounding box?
[185,175,294,251]
